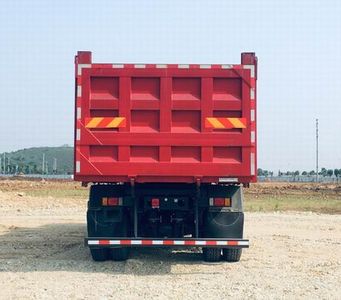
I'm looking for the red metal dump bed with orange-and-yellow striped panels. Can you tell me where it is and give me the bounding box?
[74,52,257,183]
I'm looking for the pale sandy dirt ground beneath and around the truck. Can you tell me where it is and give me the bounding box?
[0,180,341,299]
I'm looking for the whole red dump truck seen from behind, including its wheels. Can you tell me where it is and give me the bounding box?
[74,51,257,262]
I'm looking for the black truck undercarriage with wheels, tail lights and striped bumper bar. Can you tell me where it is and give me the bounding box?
[86,183,248,261]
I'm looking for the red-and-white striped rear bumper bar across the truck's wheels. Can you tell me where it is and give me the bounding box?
[85,237,249,248]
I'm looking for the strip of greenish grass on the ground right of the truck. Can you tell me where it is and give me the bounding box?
[244,194,341,214]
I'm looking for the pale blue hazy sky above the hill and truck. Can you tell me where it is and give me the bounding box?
[0,0,341,172]
